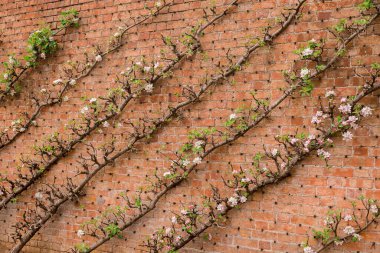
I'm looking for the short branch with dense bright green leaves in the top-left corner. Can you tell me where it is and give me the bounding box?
[0,9,79,101]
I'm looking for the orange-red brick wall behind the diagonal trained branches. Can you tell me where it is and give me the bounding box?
[0,0,380,253]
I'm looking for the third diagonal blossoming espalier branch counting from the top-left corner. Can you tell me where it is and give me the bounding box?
[0,0,226,209]
